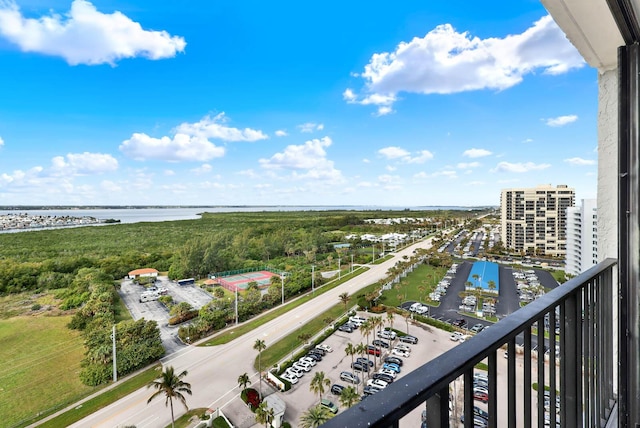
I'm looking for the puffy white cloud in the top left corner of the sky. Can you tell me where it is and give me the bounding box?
[0,0,186,65]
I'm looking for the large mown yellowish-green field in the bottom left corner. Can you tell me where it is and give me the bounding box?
[0,315,95,426]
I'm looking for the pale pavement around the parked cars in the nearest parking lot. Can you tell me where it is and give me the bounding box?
[281,313,457,427]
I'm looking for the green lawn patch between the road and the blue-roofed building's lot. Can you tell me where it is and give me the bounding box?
[381,264,447,306]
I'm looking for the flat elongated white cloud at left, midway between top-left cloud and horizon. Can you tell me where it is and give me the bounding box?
[120,133,225,161]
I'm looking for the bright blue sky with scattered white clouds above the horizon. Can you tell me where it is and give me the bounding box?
[0,0,597,206]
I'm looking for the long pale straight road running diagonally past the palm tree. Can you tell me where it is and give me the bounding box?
[71,239,440,428]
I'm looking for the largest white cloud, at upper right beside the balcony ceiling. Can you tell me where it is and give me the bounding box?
[343,15,585,113]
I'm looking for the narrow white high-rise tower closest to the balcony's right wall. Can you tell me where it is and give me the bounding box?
[565,199,598,275]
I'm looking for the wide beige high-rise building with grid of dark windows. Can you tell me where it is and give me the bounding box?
[500,184,575,257]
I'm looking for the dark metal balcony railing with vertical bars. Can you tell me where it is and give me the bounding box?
[323,259,618,428]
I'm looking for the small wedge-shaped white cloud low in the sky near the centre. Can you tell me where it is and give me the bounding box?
[259,137,342,182]
